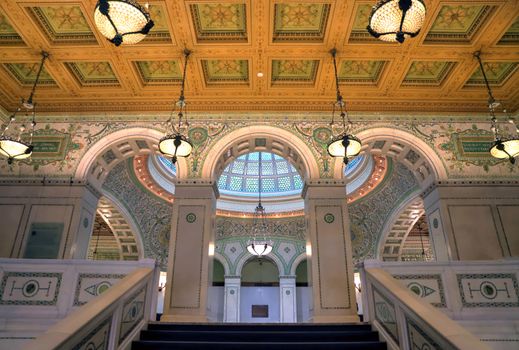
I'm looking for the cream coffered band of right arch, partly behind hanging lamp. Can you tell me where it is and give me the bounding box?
[334,127,448,188]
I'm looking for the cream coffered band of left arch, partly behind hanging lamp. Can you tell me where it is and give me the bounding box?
[75,127,188,190]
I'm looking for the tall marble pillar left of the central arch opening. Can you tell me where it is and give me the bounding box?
[161,179,218,322]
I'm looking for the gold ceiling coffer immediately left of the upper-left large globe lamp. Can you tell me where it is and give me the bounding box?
[27,5,97,44]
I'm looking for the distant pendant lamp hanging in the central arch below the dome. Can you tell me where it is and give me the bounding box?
[247,152,273,258]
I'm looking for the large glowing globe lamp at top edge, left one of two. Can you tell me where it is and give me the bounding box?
[94,0,154,46]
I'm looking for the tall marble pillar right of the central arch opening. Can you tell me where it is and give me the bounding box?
[303,179,359,323]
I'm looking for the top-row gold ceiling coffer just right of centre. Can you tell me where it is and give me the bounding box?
[272,3,331,42]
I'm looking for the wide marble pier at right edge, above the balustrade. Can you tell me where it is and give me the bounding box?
[422,181,519,261]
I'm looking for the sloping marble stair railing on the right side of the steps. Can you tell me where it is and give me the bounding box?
[360,263,490,350]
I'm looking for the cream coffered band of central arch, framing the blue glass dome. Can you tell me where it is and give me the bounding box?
[201,125,319,179]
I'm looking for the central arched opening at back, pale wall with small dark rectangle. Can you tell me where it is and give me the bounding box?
[240,258,280,323]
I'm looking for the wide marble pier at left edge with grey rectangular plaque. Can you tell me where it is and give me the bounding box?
[0,179,100,259]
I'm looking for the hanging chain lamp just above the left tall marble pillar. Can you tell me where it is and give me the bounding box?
[159,49,193,164]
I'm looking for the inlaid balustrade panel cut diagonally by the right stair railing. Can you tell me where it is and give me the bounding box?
[393,274,447,308]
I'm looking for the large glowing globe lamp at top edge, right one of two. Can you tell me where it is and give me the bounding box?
[367,0,426,43]
